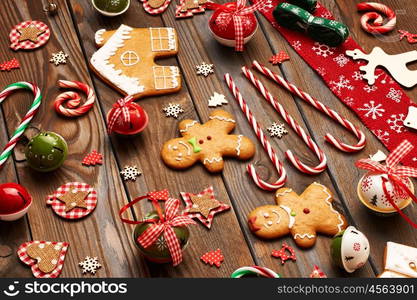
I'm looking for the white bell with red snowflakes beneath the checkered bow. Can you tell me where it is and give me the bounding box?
[358,172,414,214]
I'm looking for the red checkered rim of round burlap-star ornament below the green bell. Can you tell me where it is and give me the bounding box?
[46,182,97,220]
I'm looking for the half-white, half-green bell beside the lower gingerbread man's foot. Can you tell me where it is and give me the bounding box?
[330,226,370,273]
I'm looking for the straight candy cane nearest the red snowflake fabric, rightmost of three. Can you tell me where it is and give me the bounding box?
[253,60,366,152]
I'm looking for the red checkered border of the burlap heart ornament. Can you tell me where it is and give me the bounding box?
[17,241,69,278]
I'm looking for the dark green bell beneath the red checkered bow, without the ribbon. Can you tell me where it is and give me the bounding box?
[133,211,190,263]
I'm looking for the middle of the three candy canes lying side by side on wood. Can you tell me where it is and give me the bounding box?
[242,67,327,175]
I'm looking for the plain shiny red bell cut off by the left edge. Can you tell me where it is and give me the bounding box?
[0,183,32,215]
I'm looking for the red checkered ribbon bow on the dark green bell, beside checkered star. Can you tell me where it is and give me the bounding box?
[119,190,195,267]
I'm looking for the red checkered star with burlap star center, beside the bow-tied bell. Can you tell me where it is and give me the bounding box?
[181,186,230,229]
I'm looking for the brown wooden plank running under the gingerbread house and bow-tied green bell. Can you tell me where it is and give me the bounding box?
[71,0,253,277]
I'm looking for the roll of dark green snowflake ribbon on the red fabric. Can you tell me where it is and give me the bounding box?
[273,3,349,47]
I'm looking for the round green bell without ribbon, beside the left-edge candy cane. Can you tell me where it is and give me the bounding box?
[25,131,68,172]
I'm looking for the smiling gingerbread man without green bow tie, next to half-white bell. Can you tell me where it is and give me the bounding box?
[248,182,347,248]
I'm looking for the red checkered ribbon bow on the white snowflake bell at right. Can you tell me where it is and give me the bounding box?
[355,140,417,228]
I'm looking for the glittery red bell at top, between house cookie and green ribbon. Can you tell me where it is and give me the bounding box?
[209,2,258,40]
